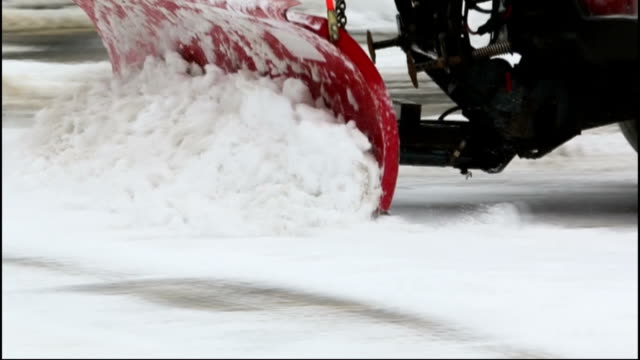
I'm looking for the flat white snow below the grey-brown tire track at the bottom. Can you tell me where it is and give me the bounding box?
[3,267,504,358]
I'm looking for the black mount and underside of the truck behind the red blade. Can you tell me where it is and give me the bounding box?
[369,0,639,173]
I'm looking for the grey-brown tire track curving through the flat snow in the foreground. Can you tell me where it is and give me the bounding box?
[2,254,556,358]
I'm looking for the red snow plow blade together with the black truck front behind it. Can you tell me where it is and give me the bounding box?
[74,0,638,212]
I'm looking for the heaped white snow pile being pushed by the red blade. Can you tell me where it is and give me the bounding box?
[8,54,380,236]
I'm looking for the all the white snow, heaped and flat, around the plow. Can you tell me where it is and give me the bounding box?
[2,0,638,358]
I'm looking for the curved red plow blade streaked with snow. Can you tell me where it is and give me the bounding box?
[74,0,399,211]
